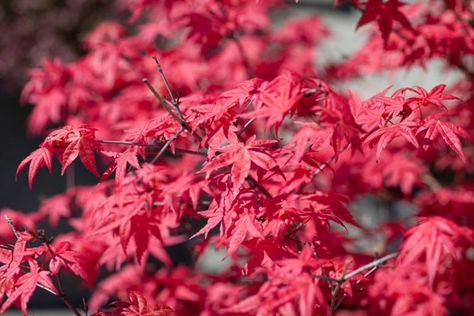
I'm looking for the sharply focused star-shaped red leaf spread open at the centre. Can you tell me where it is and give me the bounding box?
[201,135,278,189]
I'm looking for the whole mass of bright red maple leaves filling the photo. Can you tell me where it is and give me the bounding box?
[0,0,474,316]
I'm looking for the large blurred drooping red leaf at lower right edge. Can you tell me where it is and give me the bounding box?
[398,216,474,286]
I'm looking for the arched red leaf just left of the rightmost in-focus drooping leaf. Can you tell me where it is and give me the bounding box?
[365,122,419,160]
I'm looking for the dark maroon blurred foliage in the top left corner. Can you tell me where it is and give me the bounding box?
[0,0,125,93]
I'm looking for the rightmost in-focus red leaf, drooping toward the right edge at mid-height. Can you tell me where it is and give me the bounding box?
[416,115,472,163]
